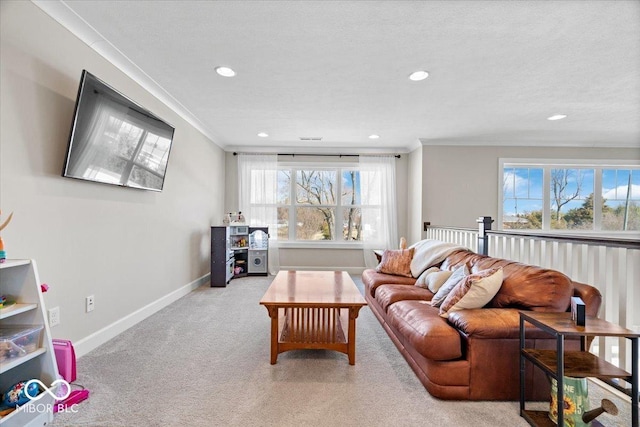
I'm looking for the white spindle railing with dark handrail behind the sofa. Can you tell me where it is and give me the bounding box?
[425,221,640,382]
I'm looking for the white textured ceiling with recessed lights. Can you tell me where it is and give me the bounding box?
[35,0,640,153]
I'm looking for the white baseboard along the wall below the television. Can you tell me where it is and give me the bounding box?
[73,273,211,358]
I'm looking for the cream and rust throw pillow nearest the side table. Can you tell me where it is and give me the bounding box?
[440,267,503,317]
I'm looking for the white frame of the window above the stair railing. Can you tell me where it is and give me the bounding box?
[496,158,640,235]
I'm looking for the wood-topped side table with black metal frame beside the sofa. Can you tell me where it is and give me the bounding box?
[520,311,640,427]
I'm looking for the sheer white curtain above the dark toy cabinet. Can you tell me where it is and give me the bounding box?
[238,154,280,274]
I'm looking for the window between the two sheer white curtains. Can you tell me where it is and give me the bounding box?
[277,165,363,242]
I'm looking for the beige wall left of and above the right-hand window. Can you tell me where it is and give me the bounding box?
[422,145,640,228]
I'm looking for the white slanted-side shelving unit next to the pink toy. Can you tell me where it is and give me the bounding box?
[0,260,58,427]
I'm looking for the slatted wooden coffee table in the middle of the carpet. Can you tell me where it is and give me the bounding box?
[260,270,367,365]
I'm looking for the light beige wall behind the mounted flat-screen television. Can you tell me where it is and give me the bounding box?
[0,0,225,350]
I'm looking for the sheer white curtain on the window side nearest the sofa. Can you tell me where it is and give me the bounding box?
[360,155,398,268]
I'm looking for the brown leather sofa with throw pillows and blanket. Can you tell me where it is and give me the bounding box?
[362,250,602,400]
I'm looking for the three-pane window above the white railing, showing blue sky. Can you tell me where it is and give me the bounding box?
[499,160,640,231]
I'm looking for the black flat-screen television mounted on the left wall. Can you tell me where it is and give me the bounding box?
[62,70,174,191]
